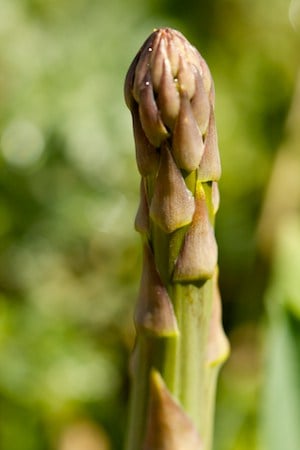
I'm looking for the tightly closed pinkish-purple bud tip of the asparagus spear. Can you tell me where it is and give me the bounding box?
[125,28,221,181]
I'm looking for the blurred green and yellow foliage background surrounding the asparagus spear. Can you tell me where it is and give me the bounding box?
[0,0,300,450]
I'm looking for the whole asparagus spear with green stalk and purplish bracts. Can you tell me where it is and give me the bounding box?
[125,28,228,450]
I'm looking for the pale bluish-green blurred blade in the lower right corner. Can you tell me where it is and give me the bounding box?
[262,311,300,450]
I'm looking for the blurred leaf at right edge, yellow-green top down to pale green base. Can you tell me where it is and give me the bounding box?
[262,218,300,450]
